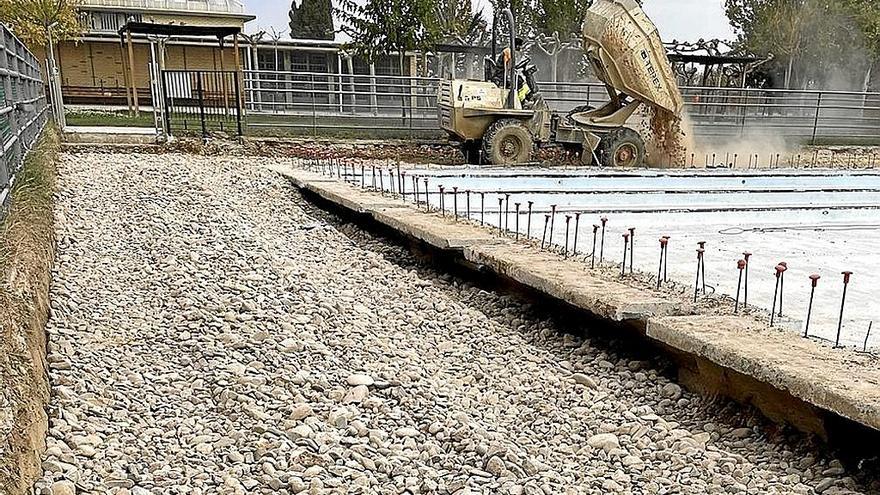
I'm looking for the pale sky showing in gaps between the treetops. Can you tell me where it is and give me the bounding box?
[243,0,733,41]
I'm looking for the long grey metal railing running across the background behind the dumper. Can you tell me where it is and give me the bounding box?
[244,71,880,143]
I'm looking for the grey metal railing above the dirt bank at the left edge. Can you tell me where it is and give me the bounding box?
[0,24,47,213]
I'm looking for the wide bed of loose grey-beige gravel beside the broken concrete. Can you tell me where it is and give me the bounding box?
[35,153,867,495]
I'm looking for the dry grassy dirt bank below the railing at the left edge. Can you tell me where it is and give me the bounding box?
[0,128,59,495]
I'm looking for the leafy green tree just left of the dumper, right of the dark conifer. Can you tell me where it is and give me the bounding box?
[336,0,437,74]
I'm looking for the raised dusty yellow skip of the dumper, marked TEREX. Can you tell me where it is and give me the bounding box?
[583,0,684,116]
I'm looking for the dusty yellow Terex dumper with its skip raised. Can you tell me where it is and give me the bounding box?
[438,0,683,167]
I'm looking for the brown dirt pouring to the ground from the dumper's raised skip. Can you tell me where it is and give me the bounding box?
[645,107,696,168]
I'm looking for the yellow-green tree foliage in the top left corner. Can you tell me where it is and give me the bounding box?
[0,0,85,48]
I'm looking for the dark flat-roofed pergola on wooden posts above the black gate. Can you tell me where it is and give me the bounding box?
[119,22,241,114]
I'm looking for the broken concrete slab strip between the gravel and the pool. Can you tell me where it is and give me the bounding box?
[273,167,880,438]
